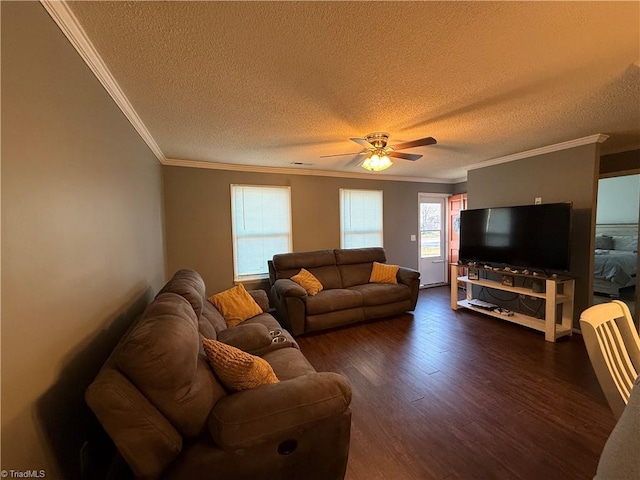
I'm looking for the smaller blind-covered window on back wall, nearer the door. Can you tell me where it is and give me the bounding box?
[340,189,383,248]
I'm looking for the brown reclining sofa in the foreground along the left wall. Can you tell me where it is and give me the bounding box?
[86,270,351,480]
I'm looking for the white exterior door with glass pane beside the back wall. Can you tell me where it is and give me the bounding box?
[418,193,447,286]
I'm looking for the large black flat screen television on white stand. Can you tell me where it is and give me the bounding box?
[459,203,571,271]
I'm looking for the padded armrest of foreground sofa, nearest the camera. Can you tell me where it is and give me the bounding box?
[209,372,351,450]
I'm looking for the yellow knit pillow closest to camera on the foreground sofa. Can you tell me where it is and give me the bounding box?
[202,338,280,392]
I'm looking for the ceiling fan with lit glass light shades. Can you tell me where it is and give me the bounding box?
[321,132,437,172]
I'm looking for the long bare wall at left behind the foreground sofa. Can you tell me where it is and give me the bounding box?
[0,2,165,478]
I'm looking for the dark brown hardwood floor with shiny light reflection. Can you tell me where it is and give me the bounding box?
[297,287,615,480]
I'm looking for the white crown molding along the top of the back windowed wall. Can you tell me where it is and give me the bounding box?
[162,158,458,184]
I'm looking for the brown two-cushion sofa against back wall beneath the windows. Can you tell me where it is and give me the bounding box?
[269,247,420,335]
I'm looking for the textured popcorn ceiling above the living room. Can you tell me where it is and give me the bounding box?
[69,2,640,181]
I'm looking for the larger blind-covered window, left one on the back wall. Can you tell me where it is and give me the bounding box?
[231,185,291,281]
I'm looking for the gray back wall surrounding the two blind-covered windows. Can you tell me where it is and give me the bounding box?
[163,166,454,293]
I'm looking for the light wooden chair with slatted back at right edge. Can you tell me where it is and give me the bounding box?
[580,300,640,418]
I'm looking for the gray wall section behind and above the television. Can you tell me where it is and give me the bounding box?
[467,144,600,328]
